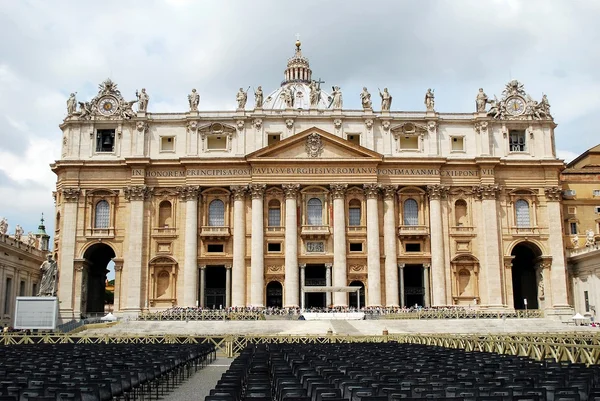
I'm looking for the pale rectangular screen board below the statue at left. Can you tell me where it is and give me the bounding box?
[14,297,58,330]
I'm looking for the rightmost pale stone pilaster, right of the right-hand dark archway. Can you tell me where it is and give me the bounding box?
[544,187,570,313]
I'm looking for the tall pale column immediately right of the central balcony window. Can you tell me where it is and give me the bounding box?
[328,184,348,307]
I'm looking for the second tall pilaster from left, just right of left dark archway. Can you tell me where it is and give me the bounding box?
[123,185,153,315]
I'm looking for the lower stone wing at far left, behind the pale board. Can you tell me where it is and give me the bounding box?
[0,218,50,327]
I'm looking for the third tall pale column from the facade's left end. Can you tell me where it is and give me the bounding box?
[177,186,200,307]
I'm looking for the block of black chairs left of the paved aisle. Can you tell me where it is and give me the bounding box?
[0,344,216,401]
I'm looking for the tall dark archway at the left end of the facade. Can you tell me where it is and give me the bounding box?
[81,244,115,315]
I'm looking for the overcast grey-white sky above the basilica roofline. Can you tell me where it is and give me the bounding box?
[0,0,600,241]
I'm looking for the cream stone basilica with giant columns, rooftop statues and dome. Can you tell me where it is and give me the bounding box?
[52,42,569,317]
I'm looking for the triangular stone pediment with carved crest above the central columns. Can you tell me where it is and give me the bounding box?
[246,127,383,162]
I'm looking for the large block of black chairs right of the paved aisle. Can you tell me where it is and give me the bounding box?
[206,343,600,401]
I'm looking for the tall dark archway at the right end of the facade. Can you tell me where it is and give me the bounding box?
[511,242,542,309]
